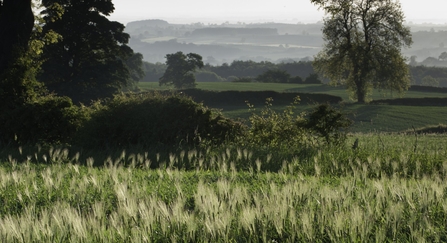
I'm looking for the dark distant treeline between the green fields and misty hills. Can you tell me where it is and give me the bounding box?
[141,61,447,87]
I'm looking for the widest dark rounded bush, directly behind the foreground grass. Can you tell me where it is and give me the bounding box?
[78,93,243,147]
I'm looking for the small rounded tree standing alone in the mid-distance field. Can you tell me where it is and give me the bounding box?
[159,51,203,89]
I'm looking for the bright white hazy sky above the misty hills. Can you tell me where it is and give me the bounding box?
[111,0,447,24]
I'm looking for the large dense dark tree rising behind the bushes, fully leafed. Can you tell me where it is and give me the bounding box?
[40,0,143,101]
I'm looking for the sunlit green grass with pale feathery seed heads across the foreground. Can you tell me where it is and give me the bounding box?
[0,134,447,242]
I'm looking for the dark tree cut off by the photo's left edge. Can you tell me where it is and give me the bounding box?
[0,0,43,108]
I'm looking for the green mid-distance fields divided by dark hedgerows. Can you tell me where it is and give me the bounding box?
[139,82,447,132]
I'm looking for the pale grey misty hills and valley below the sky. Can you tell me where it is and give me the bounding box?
[125,19,447,67]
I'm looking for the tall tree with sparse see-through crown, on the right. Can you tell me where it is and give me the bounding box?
[311,0,412,103]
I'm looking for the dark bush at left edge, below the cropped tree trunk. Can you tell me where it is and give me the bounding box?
[0,95,90,144]
